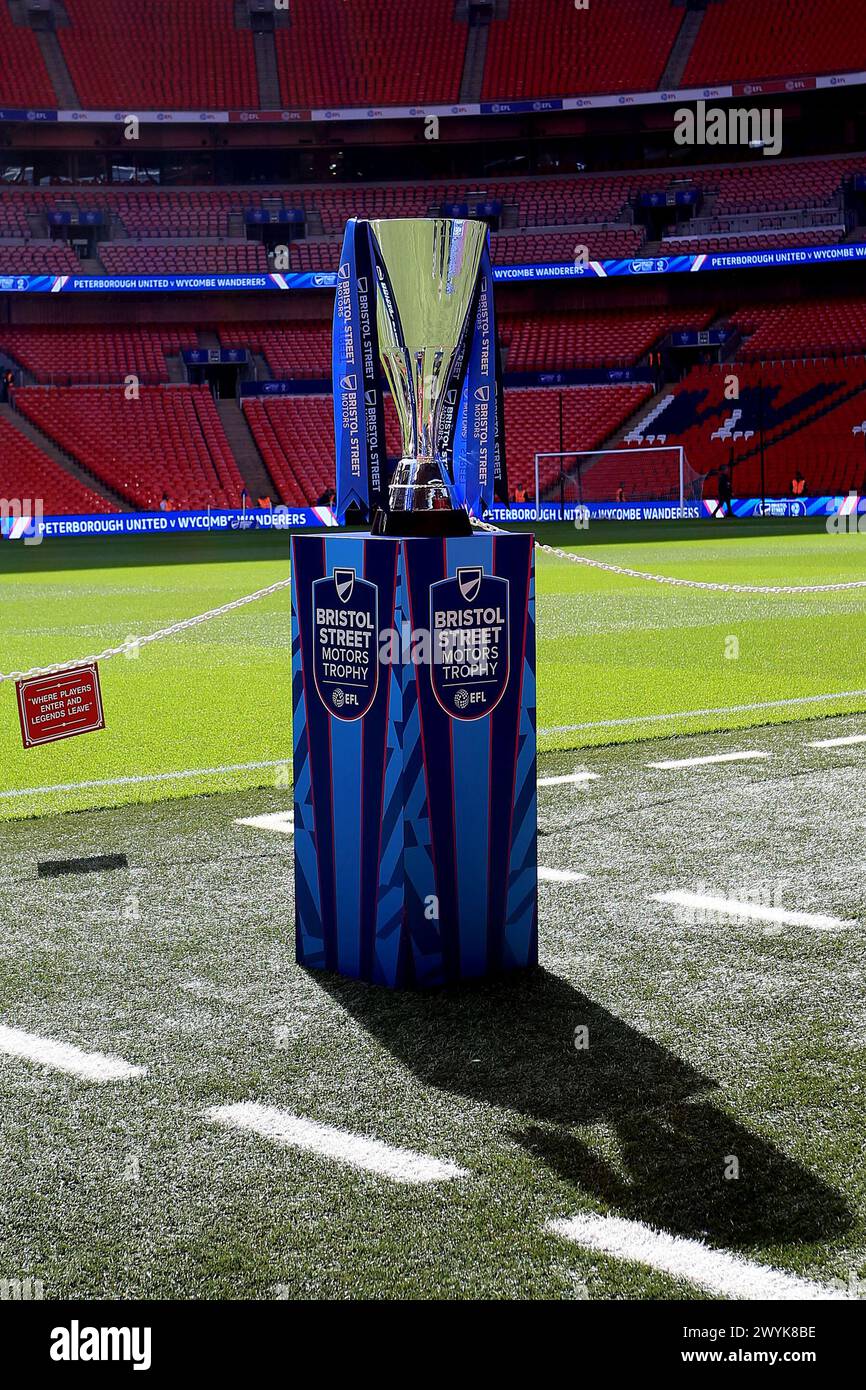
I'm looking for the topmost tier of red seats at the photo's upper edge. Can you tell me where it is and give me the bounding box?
[0,0,866,110]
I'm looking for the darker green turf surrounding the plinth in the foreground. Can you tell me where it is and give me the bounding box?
[0,716,866,1301]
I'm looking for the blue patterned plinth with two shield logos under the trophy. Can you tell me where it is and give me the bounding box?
[292,535,538,987]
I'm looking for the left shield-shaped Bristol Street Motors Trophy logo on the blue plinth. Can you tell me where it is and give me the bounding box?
[313,570,379,719]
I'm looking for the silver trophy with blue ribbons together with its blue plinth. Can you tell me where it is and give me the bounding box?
[292,218,538,986]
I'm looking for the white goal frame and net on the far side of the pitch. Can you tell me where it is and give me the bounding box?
[535,443,703,507]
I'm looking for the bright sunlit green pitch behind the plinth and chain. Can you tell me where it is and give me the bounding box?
[0,523,866,817]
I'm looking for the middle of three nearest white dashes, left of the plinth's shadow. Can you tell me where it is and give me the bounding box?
[204,1101,468,1184]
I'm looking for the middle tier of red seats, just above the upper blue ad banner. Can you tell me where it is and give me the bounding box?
[0,154,866,275]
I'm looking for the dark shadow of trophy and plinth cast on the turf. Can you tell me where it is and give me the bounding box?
[313,970,852,1247]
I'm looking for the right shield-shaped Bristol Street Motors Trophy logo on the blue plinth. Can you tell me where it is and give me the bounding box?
[430,566,510,719]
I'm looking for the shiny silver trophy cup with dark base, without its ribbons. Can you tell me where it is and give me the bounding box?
[370,217,487,535]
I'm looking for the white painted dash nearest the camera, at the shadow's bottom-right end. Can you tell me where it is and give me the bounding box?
[548,1216,848,1301]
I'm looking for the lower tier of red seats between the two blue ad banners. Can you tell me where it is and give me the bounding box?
[8,296,866,512]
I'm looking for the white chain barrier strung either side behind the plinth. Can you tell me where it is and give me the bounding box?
[0,518,866,685]
